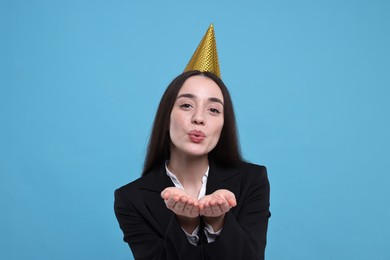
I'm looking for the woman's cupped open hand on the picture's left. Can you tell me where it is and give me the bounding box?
[161,187,199,218]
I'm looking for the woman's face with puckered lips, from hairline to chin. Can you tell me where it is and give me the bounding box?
[169,75,224,157]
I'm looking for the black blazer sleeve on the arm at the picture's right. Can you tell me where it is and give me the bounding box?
[201,165,271,260]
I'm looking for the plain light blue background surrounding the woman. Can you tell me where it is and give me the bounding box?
[0,0,390,260]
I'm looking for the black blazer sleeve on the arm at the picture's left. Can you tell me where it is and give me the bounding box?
[114,189,204,260]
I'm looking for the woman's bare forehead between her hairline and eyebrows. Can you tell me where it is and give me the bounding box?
[178,75,223,100]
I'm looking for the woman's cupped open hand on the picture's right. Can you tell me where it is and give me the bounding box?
[199,189,237,217]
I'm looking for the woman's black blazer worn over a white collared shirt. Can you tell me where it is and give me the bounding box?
[114,163,271,260]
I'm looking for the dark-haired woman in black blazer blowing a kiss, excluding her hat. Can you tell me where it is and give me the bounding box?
[115,24,270,260]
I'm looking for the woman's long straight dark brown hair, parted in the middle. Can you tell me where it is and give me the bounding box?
[142,70,242,175]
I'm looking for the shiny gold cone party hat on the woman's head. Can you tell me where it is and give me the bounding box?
[184,24,221,78]
